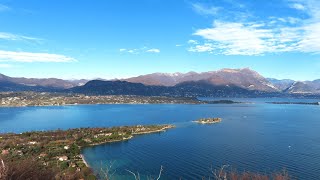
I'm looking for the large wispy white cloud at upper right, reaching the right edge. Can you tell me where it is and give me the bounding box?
[188,0,320,55]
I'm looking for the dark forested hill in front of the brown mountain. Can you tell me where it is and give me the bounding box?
[69,80,279,97]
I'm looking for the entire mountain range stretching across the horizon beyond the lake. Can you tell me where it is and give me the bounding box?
[0,68,320,96]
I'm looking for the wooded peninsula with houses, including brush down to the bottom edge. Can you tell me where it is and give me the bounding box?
[0,125,174,179]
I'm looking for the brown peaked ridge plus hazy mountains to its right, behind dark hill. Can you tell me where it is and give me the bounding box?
[123,68,320,94]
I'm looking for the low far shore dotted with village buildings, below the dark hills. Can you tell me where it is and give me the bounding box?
[0,92,206,107]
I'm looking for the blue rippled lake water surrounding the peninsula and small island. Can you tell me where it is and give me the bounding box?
[0,99,320,179]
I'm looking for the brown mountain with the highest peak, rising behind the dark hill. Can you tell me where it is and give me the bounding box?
[124,68,280,92]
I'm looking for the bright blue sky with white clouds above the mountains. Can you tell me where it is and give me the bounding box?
[0,0,320,80]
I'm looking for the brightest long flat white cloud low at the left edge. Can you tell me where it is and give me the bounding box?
[0,50,76,63]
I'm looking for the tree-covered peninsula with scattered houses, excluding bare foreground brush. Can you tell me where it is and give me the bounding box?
[0,124,175,179]
